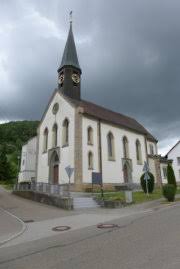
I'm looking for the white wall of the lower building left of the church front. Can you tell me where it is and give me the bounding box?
[18,137,37,182]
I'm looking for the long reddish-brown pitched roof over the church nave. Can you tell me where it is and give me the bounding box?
[64,93,157,142]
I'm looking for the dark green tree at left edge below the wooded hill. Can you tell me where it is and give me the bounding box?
[0,145,11,181]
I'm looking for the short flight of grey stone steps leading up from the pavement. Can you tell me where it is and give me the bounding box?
[73,197,99,209]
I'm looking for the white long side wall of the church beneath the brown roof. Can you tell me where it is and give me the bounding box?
[83,117,146,184]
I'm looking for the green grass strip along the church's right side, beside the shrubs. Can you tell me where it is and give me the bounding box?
[97,188,180,204]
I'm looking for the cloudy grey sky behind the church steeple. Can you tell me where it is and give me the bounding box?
[0,0,180,153]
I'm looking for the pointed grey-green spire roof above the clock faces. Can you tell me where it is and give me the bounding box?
[59,23,81,70]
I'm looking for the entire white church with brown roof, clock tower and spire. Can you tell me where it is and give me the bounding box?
[18,23,167,190]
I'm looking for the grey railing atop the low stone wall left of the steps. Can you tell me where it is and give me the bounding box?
[14,182,69,196]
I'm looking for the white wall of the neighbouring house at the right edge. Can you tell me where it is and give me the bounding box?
[168,143,180,182]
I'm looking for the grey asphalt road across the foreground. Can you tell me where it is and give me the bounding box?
[0,204,180,269]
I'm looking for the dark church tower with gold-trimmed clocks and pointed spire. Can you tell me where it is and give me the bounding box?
[58,15,81,100]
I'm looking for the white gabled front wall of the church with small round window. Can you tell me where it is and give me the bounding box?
[37,92,75,184]
